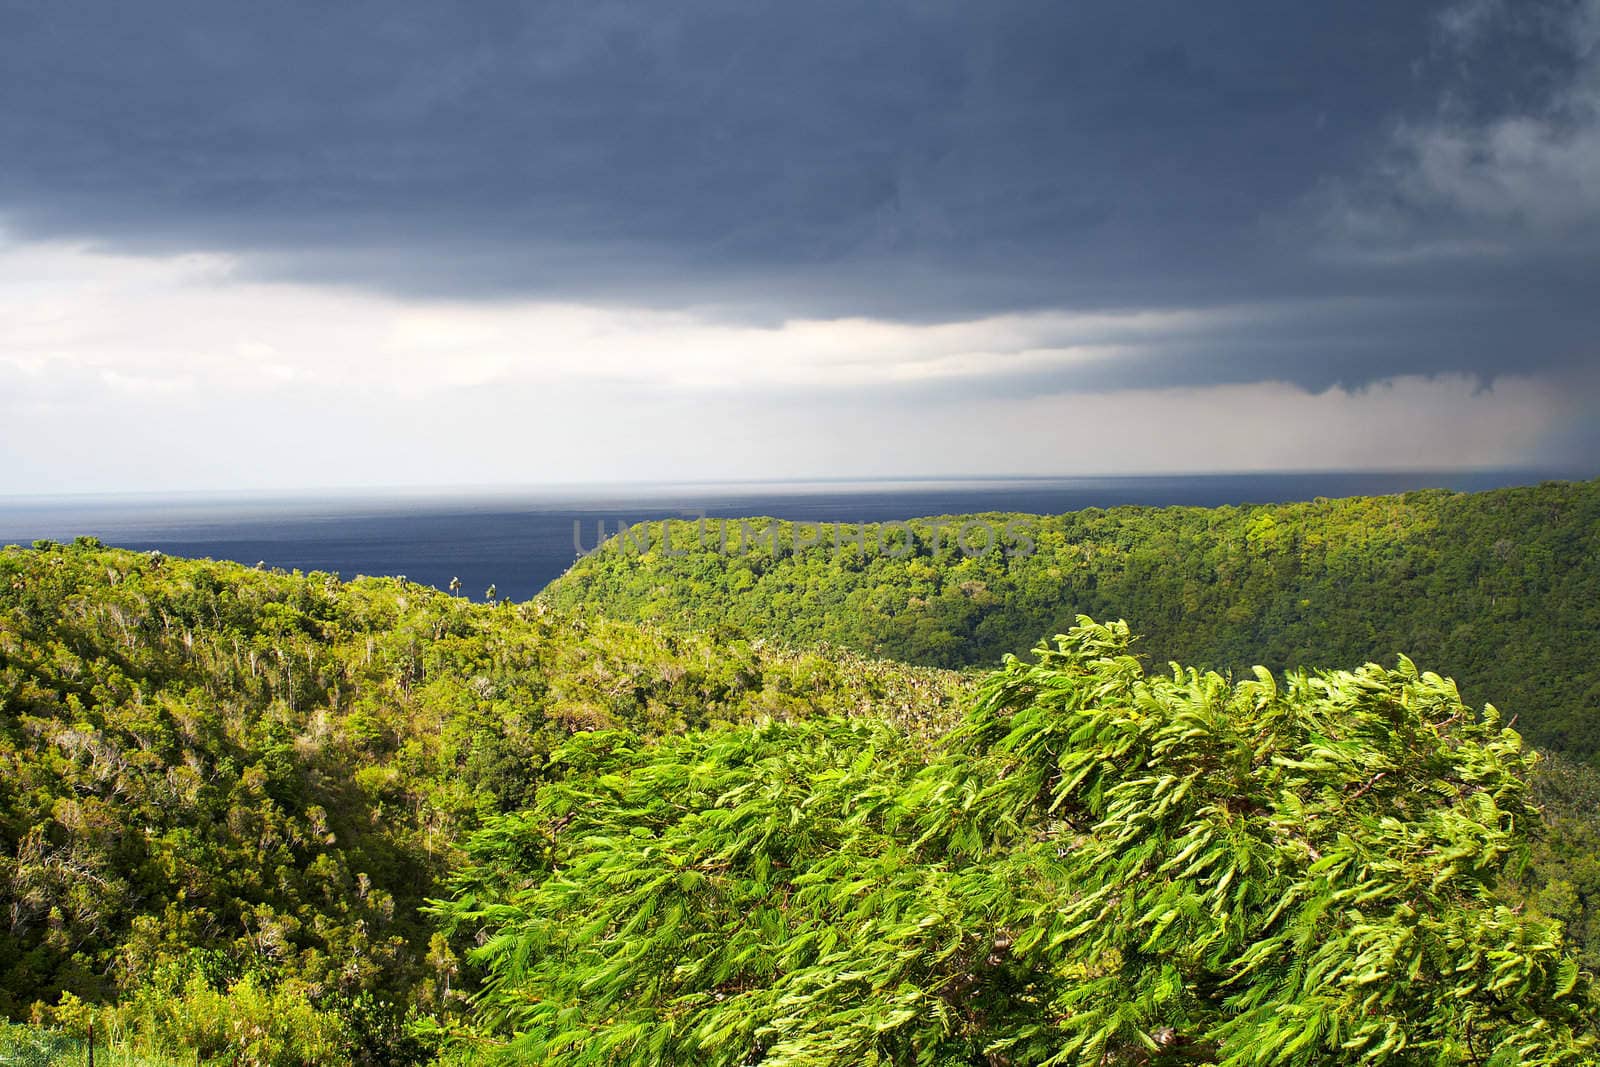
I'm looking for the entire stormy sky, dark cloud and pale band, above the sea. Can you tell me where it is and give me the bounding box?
[0,0,1600,493]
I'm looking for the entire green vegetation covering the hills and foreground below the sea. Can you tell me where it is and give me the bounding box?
[0,483,1600,1067]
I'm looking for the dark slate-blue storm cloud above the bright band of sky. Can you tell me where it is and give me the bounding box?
[0,0,1600,389]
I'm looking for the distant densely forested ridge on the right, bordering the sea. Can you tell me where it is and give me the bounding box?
[542,482,1600,758]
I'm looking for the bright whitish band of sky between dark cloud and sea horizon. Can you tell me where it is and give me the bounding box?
[0,245,1592,493]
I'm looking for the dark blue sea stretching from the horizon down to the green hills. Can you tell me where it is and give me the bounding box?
[0,470,1571,600]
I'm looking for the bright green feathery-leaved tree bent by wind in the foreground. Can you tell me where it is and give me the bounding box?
[437,619,1597,1067]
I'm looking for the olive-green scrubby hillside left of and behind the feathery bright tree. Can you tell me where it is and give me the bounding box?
[0,541,965,1062]
